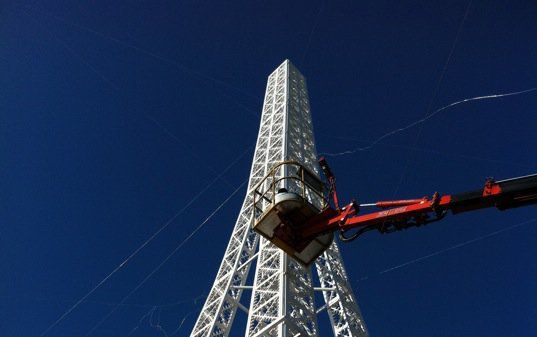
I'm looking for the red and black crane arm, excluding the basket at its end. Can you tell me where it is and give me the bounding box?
[299,158,537,241]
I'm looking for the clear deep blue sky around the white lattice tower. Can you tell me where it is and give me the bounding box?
[0,0,537,337]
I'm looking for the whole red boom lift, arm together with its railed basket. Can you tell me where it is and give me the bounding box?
[251,158,537,265]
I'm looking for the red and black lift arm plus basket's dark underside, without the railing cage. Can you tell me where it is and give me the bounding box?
[253,158,537,265]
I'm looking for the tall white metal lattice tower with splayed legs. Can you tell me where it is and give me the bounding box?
[190,60,368,337]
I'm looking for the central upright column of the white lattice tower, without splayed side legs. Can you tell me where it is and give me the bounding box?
[246,60,320,337]
